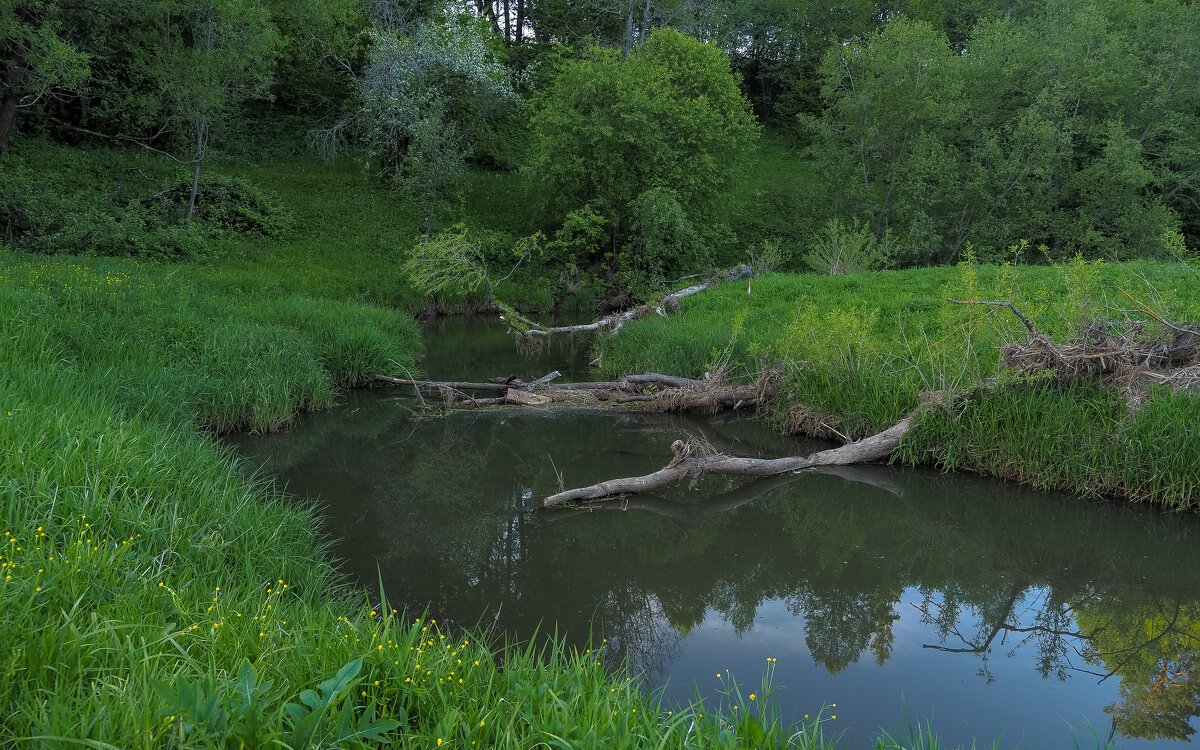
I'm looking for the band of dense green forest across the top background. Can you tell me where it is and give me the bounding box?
[0,0,1200,304]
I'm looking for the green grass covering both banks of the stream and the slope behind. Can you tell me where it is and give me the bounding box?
[0,144,1200,748]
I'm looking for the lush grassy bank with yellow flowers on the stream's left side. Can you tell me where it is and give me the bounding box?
[0,254,873,749]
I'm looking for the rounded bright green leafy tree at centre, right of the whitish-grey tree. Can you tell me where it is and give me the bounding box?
[527,29,758,285]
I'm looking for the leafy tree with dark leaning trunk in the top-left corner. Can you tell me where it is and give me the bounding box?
[0,0,89,154]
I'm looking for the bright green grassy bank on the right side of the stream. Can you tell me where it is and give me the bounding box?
[598,262,1200,509]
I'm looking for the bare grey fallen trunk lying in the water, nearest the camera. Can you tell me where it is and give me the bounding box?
[542,414,917,508]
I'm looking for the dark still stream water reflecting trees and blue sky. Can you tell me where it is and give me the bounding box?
[235,322,1200,748]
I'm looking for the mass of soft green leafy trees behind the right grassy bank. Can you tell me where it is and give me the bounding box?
[804,0,1200,265]
